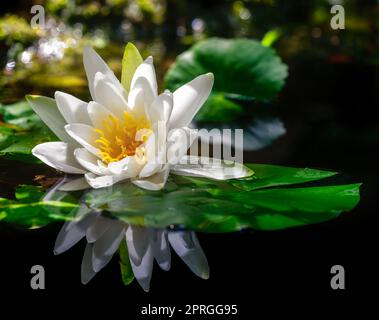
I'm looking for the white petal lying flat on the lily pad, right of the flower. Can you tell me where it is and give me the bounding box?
[171,156,252,180]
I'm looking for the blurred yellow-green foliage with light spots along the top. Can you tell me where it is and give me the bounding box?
[0,0,379,103]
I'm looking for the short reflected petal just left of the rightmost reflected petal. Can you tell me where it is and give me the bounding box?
[151,229,171,271]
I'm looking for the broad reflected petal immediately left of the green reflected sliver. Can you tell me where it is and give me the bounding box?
[92,223,125,272]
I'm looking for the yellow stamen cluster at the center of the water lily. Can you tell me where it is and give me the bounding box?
[95,111,152,164]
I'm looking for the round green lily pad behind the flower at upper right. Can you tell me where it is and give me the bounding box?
[164,38,288,122]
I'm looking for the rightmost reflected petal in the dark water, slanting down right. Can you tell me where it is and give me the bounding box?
[168,231,209,279]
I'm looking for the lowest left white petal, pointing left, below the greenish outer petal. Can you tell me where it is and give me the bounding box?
[32,142,85,174]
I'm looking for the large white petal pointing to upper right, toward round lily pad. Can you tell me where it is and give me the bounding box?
[170,73,214,129]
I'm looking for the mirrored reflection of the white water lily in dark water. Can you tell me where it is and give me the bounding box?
[44,180,209,291]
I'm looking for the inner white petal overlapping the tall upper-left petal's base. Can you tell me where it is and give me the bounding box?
[94,72,129,119]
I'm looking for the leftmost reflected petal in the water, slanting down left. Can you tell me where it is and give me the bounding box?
[54,213,98,254]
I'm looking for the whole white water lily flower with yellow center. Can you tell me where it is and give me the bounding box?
[27,47,248,190]
